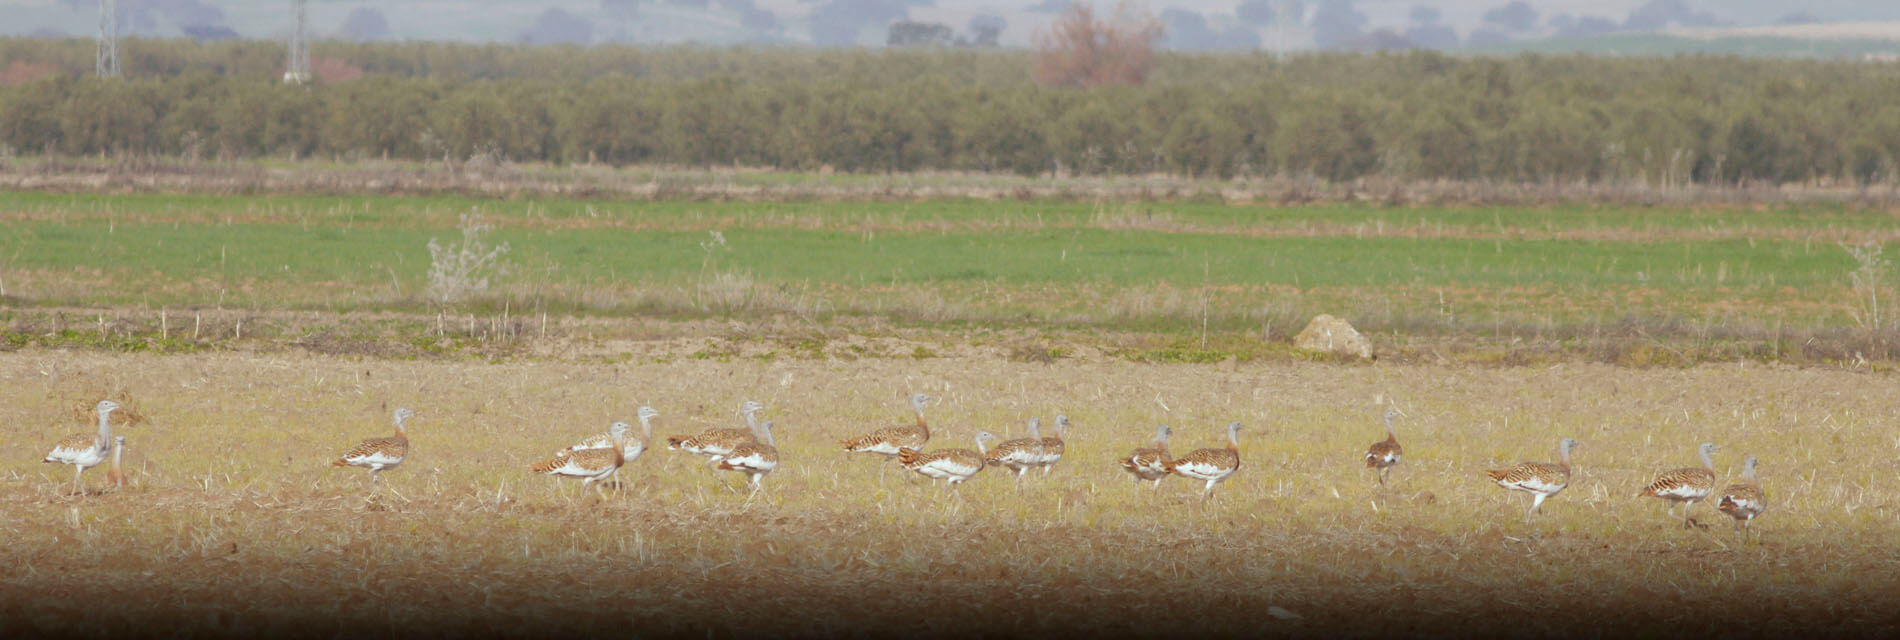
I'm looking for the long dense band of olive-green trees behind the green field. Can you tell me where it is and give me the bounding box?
[11,40,1900,184]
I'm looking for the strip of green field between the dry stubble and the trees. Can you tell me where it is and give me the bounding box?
[0,194,1900,353]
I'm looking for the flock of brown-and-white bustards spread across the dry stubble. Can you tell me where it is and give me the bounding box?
[44,393,1767,532]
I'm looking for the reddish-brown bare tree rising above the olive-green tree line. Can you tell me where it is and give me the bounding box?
[1036,2,1161,87]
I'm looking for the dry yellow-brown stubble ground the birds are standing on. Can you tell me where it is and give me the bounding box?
[0,349,1900,636]
